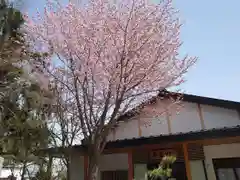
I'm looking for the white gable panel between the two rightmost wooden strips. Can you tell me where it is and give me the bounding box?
[171,102,201,133]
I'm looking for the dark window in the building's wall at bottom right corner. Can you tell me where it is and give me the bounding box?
[213,158,240,180]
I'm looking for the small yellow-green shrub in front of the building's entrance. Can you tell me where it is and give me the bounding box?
[148,156,176,180]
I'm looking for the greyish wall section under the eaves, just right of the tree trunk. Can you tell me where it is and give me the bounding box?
[99,153,128,171]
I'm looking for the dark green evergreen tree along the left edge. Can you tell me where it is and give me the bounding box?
[0,0,51,179]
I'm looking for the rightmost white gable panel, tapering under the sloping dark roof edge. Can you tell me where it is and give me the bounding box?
[201,105,240,129]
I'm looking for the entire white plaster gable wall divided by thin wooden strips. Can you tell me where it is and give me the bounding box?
[108,102,240,141]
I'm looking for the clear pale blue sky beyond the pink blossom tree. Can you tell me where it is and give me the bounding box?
[25,0,240,101]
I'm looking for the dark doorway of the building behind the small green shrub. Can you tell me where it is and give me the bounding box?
[147,162,187,180]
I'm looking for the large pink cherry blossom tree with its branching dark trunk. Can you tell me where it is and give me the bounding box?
[24,0,196,180]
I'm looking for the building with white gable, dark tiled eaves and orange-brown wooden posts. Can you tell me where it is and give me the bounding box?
[66,94,240,180]
